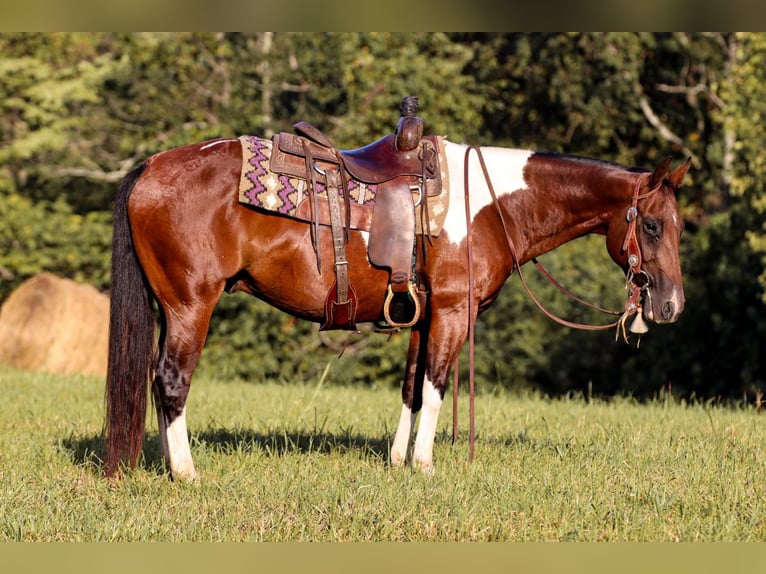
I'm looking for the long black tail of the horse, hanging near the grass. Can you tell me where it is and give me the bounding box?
[105,164,155,476]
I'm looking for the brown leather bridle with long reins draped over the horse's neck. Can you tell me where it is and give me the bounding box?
[452,146,662,461]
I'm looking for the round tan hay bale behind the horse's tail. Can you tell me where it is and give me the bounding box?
[0,273,109,377]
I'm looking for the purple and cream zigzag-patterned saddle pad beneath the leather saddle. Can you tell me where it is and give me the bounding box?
[239,134,449,237]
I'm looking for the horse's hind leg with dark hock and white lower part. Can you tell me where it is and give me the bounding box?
[152,304,218,481]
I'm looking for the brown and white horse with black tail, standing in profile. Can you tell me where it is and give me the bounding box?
[104,130,690,481]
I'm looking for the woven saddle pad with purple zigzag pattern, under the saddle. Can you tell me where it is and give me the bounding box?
[239,136,449,236]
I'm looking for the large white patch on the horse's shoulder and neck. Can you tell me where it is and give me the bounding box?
[444,141,534,244]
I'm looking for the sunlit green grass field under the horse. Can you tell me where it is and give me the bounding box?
[0,367,766,541]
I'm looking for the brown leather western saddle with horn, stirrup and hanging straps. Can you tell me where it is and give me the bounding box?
[270,96,441,330]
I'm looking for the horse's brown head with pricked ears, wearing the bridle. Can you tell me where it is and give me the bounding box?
[607,158,690,323]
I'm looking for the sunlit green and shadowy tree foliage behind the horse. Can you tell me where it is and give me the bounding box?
[0,32,766,396]
